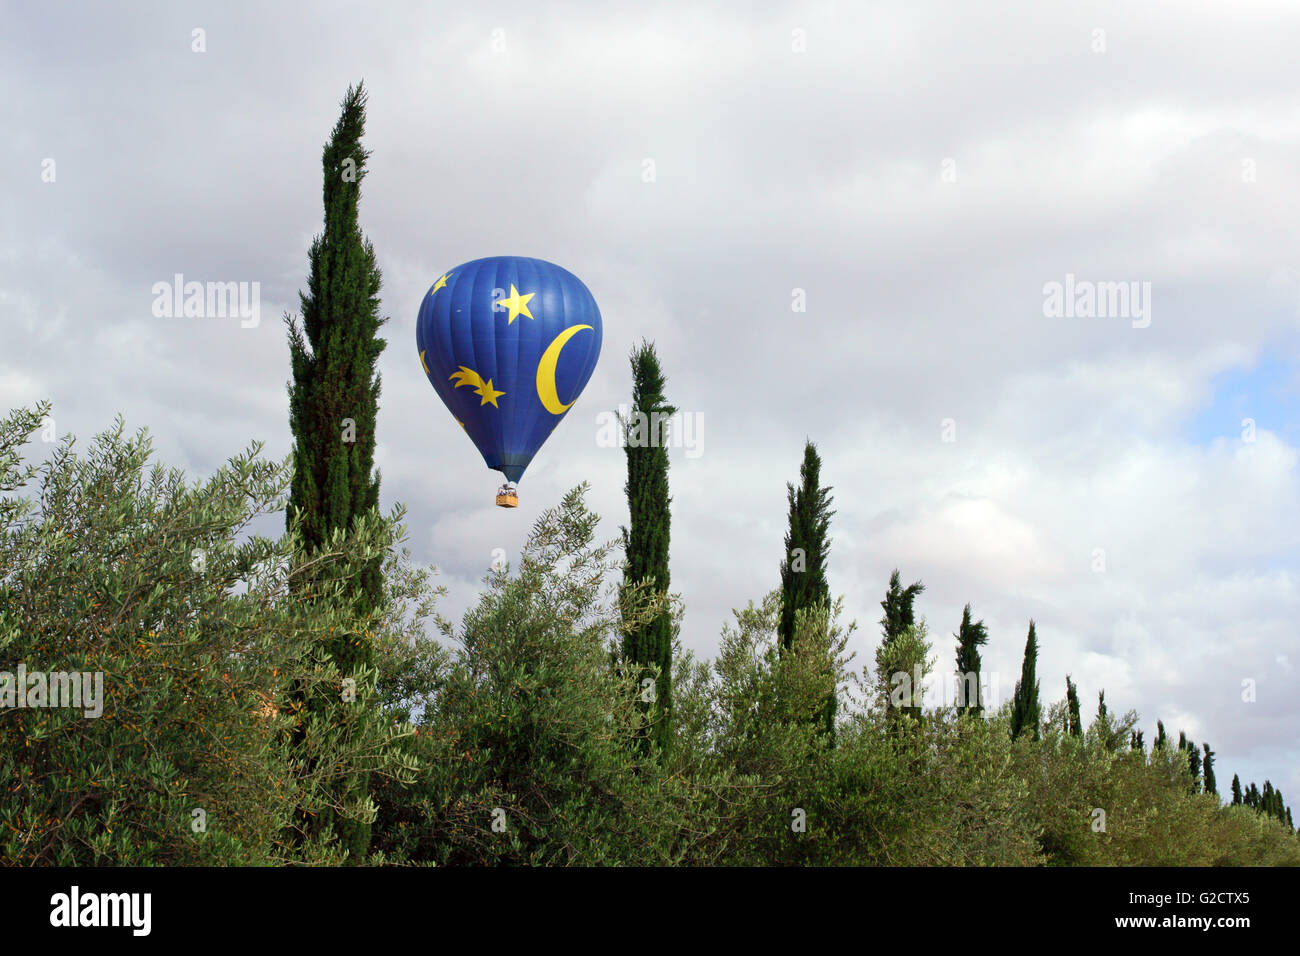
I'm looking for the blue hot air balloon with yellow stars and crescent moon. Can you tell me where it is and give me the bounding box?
[415,256,602,507]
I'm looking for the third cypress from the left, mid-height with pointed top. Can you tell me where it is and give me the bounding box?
[779,441,836,734]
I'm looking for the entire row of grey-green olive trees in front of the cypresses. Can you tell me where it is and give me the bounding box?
[0,407,1300,866]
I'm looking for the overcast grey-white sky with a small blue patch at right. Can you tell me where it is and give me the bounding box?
[0,0,1300,801]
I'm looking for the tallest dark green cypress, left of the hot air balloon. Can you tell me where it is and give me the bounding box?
[286,83,385,861]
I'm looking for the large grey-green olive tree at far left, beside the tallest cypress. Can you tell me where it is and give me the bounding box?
[0,407,411,865]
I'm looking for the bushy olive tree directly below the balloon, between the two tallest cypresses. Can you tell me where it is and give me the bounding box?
[380,489,693,865]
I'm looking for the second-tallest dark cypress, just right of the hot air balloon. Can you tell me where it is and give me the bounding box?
[623,341,677,749]
